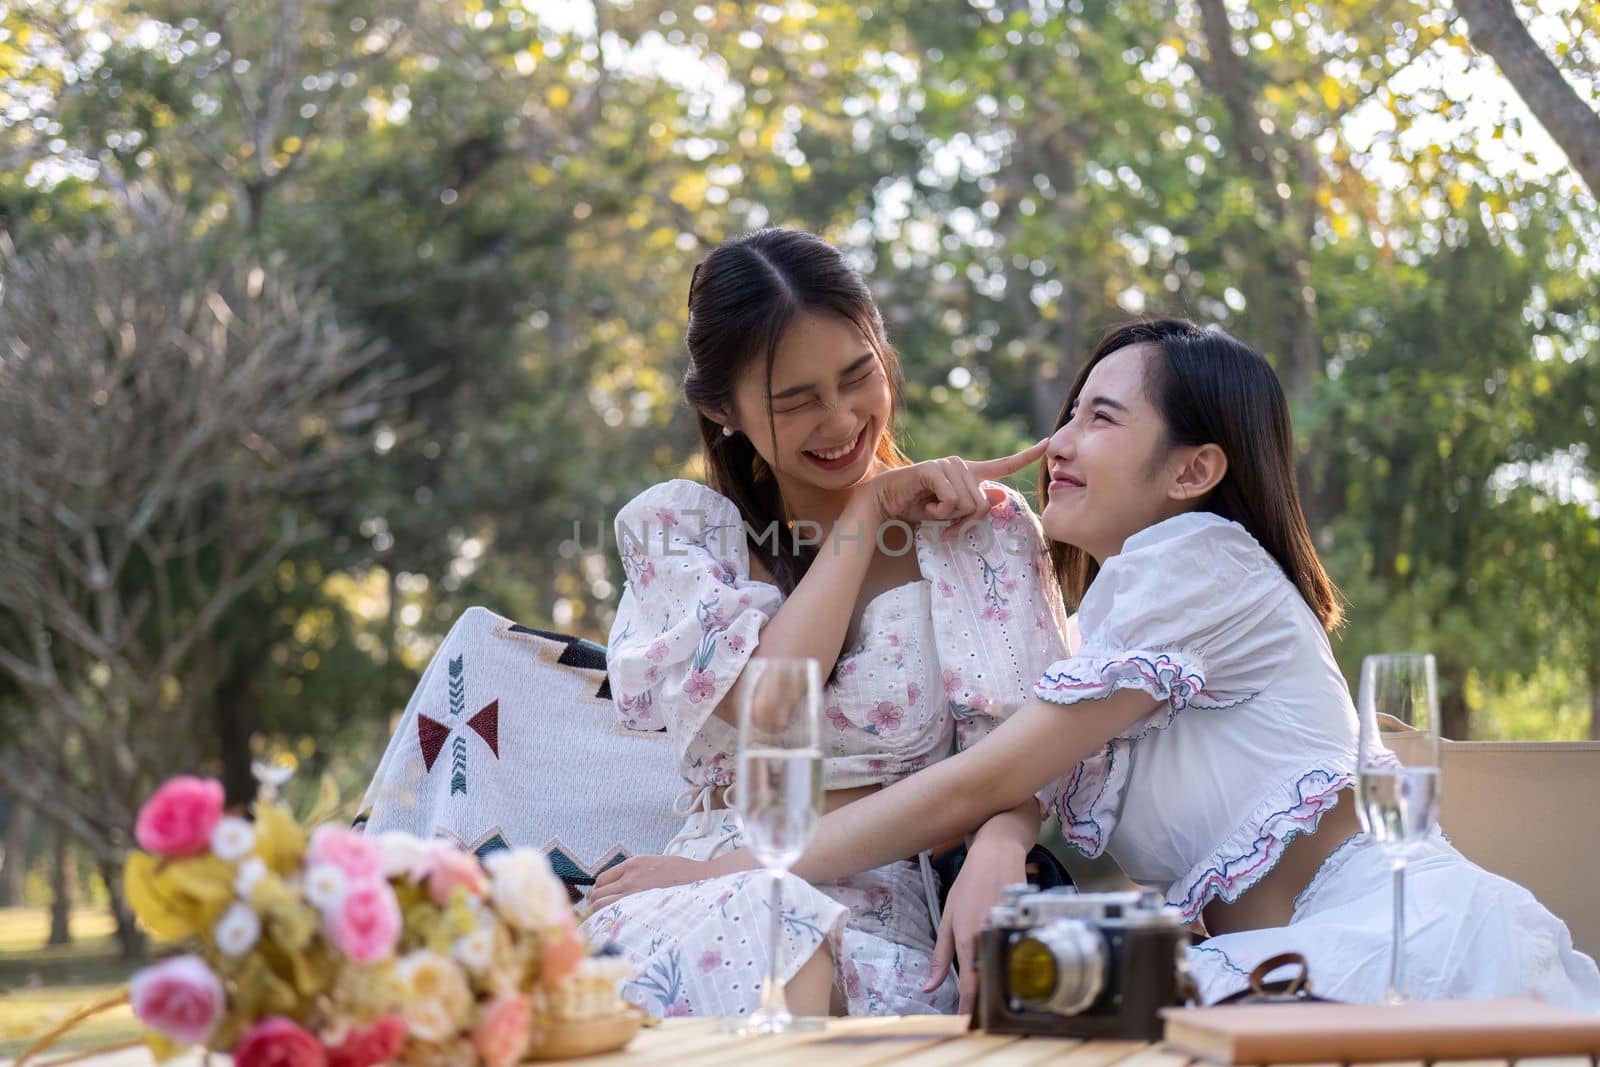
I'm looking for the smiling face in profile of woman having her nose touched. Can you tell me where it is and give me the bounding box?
[1040,344,1184,563]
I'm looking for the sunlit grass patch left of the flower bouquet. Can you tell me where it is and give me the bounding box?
[0,907,139,1059]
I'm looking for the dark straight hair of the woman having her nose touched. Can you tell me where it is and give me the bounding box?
[1040,318,1344,630]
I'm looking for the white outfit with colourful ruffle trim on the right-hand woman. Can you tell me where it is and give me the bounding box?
[1035,514,1600,1009]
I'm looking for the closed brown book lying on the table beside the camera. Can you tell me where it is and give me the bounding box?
[1162,1000,1600,1064]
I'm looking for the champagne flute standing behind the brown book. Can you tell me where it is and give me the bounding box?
[1355,653,1440,1005]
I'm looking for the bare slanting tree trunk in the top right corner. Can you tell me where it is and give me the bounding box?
[1456,0,1600,197]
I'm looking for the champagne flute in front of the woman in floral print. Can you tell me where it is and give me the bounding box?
[736,659,822,1033]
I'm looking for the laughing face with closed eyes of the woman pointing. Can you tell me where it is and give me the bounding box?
[733,303,894,498]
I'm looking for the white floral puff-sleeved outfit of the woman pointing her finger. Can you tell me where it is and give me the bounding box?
[584,480,1064,1016]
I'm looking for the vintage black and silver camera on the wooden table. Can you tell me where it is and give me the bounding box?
[974,886,1189,1041]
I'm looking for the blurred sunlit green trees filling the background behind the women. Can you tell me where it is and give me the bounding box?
[0,0,1600,831]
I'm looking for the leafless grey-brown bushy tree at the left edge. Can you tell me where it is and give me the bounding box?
[0,212,402,953]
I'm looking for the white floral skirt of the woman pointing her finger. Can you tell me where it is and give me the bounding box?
[582,809,957,1017]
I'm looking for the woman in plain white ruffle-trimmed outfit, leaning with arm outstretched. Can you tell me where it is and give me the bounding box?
[614,320,1600,1009]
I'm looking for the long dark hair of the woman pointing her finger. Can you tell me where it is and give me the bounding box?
[683,227,909,595]
